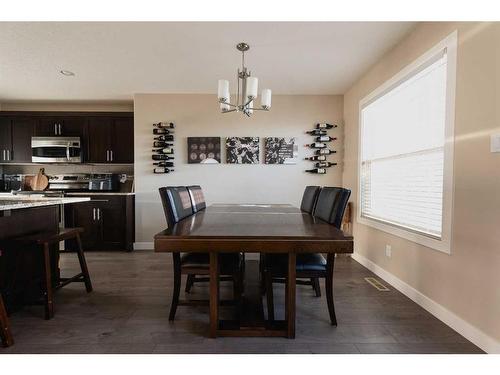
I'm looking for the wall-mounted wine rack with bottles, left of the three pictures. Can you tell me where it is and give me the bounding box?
[151,122,175,174]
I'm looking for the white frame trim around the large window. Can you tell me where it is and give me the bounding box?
[356,30,458,254]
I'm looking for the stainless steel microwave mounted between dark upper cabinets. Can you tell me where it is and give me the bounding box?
[31,137,82,163]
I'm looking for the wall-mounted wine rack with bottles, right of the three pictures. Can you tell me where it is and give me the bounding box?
[305,123,338,174]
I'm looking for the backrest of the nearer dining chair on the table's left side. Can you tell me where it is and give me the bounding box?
[158,186,193,227]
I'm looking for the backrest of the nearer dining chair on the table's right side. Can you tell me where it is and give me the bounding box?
[313,187,351,229]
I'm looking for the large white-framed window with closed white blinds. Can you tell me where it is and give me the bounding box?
[358,32,456,252]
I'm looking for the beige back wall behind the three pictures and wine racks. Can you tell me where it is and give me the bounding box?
[134,94,343,242]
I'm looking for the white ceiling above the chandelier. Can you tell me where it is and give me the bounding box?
[0,22,415,101]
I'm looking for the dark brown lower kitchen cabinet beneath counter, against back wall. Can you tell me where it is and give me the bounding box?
[64,195,135,251]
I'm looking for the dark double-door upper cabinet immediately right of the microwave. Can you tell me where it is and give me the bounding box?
[88,117,134,164]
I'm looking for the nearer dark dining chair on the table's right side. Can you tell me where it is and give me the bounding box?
[264,187,351,325]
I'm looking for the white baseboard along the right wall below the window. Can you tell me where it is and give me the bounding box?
[352,253,500,354]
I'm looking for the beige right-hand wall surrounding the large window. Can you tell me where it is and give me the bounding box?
[343,23,500,348]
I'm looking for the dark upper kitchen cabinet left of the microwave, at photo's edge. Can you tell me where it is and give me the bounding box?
[0,117,35,163]
